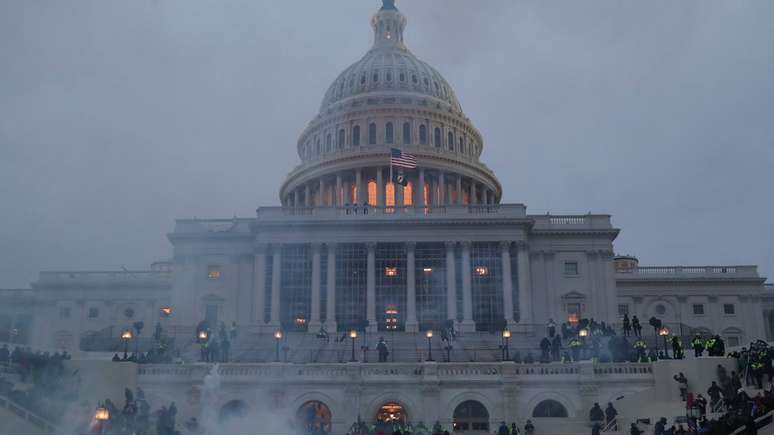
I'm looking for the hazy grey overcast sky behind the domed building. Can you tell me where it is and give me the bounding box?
[0,0,774,288]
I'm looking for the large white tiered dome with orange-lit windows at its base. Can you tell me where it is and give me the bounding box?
[280,0,502,207]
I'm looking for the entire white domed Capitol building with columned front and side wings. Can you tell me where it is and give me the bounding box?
[0,1,774,430]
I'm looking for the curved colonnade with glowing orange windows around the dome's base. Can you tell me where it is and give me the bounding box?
[282,167,499,207]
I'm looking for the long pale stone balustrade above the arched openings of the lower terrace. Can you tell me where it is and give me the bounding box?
[138,362,653,383]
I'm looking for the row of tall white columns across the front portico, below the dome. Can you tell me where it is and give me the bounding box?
[254,241,532,332]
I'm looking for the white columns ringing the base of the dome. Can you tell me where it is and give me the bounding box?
[284,168,497,207]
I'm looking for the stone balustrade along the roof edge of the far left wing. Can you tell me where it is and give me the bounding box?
[33,271,172,287]
